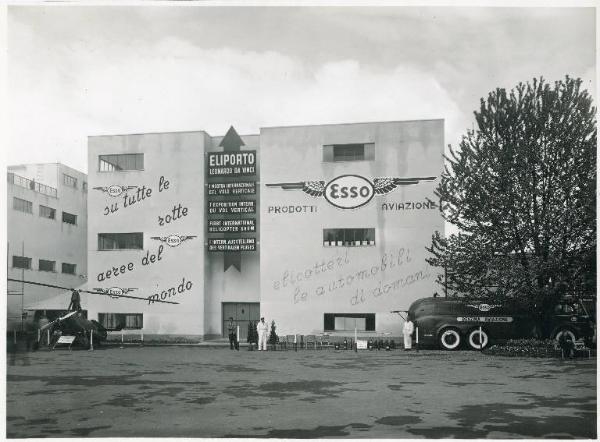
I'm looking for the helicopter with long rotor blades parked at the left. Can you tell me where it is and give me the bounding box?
[7,278,179,349]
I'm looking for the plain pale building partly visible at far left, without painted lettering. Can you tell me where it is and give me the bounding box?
[7,163,88,330]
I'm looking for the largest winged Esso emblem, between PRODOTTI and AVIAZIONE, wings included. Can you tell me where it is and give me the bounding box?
[267,175,436,209]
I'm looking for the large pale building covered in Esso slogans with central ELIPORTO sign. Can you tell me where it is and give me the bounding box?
[28,120,444,340]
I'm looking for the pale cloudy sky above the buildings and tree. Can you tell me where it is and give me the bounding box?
[7,5,596,172]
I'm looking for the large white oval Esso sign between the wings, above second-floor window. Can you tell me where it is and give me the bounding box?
[325,175,375,209]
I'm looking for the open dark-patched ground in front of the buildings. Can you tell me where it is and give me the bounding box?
[7,347,597,438]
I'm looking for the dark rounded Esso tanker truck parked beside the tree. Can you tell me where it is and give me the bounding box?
[408,298,595,350]
